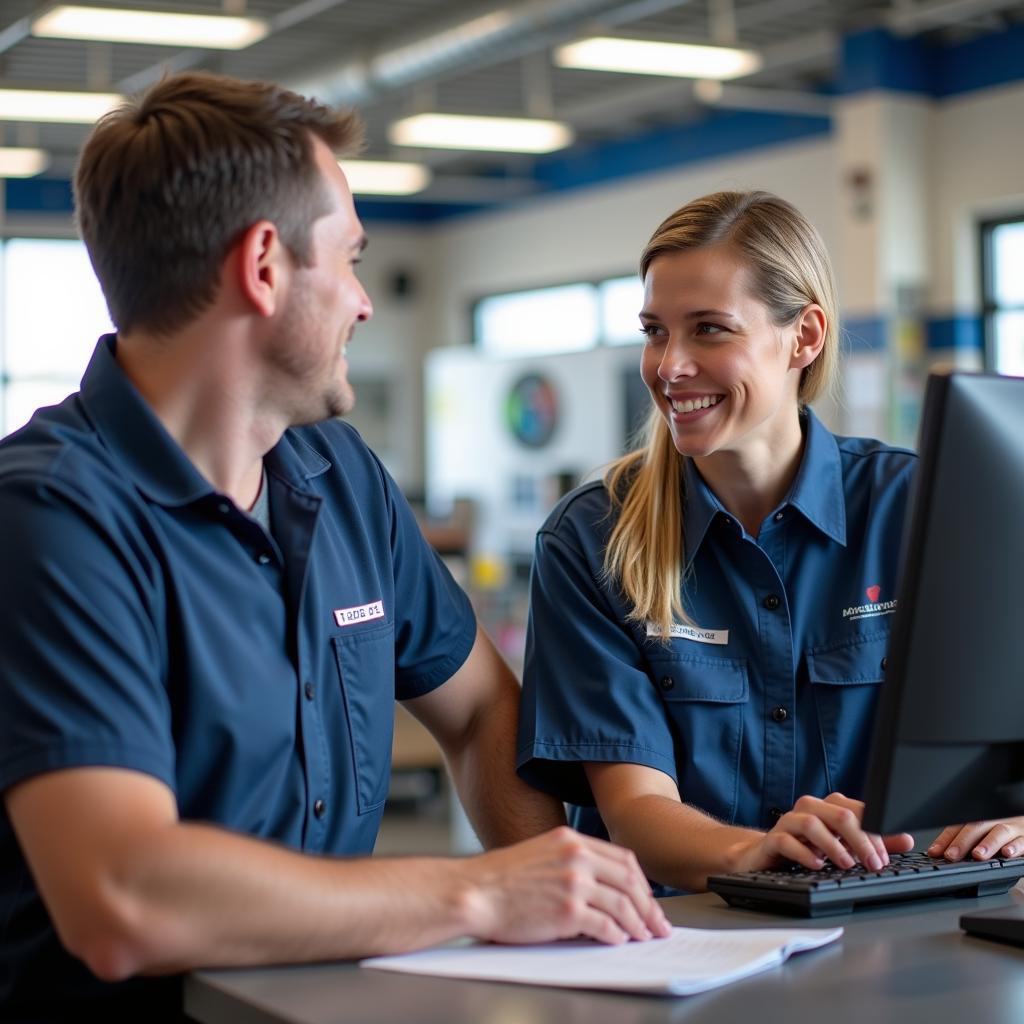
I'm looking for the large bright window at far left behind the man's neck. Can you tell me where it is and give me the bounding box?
[0,239,113,434]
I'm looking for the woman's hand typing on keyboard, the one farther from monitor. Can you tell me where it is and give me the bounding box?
[732,793,913,871]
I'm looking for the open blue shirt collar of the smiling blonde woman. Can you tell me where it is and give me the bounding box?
[683,409,846,570]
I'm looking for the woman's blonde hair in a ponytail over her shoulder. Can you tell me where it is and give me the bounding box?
[604,191,839,638]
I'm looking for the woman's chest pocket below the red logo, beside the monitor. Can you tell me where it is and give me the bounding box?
[806,633,889,798]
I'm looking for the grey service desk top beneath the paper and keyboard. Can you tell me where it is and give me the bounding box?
[185,889,1024,1024]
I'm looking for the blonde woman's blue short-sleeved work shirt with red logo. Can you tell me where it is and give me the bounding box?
[518,411,915,851]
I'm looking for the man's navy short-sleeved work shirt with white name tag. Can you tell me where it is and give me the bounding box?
[0,337,476,1019]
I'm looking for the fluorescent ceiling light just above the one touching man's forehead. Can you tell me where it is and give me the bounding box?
[388,114,572,153]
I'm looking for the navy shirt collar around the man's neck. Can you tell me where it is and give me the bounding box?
[81,334,331,506]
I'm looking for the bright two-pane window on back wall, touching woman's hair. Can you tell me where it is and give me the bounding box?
[473,276,643,356]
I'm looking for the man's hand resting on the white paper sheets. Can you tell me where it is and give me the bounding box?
[466,827,672,944]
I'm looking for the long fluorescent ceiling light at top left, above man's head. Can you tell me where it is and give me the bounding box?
[32,4,268,50]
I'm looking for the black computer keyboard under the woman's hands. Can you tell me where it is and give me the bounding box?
[708,853,1024,918]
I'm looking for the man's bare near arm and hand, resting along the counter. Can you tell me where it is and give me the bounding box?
[5,768,668,981]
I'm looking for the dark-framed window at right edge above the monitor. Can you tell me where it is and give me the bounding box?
[981,216,1024,377]
